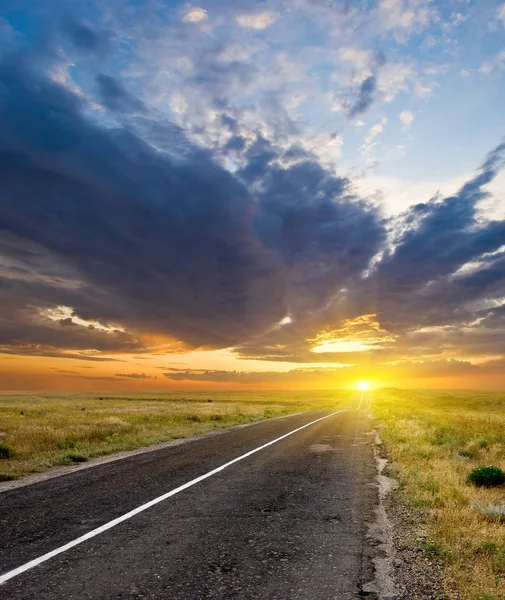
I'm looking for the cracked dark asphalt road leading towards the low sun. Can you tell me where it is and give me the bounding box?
[0,410,377,600]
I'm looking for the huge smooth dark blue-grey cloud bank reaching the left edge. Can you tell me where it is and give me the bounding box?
[0,56,306,347]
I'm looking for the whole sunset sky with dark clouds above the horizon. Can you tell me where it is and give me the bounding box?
[0,0,505,391]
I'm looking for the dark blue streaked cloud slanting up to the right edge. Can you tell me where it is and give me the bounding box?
[361,143,505,328]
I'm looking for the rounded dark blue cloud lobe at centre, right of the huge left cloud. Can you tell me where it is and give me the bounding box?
[252,156,385,318]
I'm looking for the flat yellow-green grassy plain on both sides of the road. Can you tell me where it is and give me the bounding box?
[0,389,505,600]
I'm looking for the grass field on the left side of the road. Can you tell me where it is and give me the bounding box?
[0,392,353,481]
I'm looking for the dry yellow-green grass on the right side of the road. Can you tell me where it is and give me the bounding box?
[372,390,505,600]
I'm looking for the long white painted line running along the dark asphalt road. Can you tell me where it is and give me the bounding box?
[0,409,346,585]
